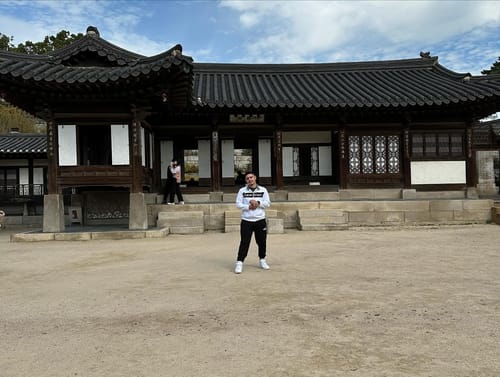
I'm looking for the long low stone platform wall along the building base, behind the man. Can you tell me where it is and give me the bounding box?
[148,199,493,232]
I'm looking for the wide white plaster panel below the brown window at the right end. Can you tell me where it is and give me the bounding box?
[411,161,466,185]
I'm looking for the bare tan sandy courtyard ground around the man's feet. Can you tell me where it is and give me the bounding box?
[0,225,500,377]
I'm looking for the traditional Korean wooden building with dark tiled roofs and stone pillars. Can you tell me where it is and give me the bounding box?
[0,27,500,231]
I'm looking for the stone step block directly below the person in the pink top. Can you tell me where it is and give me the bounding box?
[157,211,205,234]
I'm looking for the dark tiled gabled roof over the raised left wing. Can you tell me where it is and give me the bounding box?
[0,28,193,103]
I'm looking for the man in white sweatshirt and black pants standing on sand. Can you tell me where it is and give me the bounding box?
[234,173,271,274]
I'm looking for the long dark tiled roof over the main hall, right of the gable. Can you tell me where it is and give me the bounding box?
[193,56,500,109]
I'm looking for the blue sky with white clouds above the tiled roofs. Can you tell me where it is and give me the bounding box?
[0,0,500,75]
